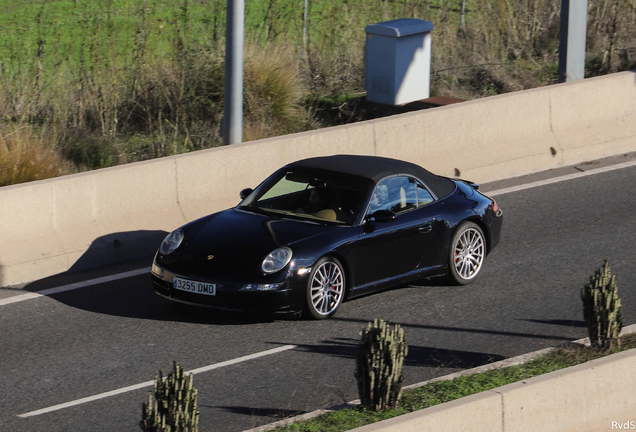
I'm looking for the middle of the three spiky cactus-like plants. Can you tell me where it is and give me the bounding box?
[355,318,408,411]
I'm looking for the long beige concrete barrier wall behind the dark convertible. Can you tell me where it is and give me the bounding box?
[0,72,636,286]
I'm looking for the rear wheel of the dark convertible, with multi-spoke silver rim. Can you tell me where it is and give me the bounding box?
[448,222,486,285]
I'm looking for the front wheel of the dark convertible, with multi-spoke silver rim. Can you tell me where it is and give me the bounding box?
[305,257,346,319]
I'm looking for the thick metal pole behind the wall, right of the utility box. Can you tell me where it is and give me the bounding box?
[559,0,587,82]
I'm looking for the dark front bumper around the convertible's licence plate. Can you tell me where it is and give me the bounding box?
[151,262,305,313]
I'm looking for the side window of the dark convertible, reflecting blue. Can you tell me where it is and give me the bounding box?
[369,176,418,214]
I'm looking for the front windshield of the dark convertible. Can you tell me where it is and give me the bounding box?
[238,169,372,225]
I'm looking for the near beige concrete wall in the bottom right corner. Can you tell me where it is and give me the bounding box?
[352,350,636,432]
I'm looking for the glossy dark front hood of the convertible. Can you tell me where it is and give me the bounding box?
[166,209,336,279]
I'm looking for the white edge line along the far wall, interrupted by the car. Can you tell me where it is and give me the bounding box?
[0,161,636,306]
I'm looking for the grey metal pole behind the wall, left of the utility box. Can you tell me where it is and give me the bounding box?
[221,0,245,145]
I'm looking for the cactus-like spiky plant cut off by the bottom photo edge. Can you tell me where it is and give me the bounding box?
[139,361,199,432]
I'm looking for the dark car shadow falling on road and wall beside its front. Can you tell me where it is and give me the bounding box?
[16,231,284,325]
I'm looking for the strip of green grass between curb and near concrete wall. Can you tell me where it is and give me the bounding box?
[272,335,636,432]
